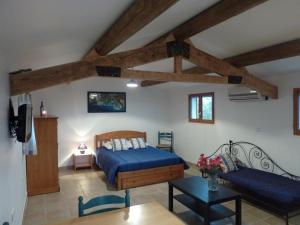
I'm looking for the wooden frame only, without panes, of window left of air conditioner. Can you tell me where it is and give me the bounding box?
[188,92,214,125]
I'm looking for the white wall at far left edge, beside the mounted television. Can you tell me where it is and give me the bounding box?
[0,52,27,225]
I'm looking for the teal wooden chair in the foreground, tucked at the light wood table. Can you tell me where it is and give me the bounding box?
[78,190,130,217]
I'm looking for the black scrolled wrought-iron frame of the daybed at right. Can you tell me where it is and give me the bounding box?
[209,141,300,225]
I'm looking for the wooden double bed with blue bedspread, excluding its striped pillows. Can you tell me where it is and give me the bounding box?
[95,130,188,190]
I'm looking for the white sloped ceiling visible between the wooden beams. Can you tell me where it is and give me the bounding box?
[0,0,300,79]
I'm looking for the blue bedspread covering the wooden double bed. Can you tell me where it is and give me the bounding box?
[96,146,188,185]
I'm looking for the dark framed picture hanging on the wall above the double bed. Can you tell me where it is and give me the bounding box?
[87,91,126,113]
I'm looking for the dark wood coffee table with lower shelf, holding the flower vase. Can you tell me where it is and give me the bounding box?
[169,176,242,225]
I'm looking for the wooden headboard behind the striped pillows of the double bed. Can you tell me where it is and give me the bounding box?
[95,130,147,149]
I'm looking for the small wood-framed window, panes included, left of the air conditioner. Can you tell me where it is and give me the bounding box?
[189,92,215,123]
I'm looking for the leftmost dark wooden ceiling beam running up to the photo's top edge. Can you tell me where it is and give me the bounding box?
[83,0,178,61]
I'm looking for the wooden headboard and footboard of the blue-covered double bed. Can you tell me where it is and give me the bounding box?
[95,130,184,190]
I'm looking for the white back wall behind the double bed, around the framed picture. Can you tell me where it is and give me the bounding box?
[32,77,169,166]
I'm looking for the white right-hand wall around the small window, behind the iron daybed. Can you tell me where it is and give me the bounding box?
[170,74,300,175]
